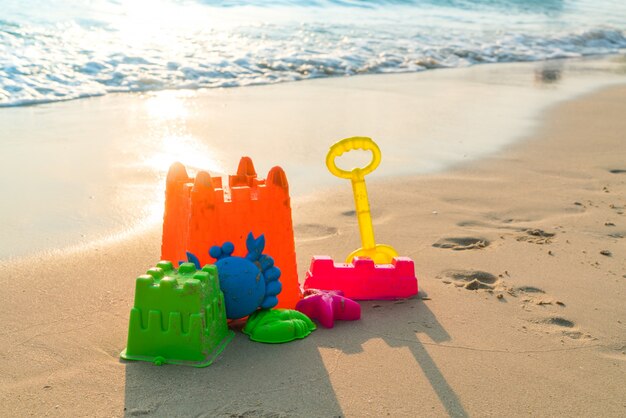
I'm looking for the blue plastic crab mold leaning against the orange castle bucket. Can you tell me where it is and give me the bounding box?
[209,233,282,319]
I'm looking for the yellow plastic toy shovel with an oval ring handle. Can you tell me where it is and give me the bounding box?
[326,136,398,264]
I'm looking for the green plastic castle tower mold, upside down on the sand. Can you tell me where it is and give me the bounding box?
[120,261,233,367]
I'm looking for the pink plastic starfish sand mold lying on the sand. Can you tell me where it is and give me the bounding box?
[296,289,361,328]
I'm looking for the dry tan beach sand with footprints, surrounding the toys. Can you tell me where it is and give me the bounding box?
[0,59,626,417]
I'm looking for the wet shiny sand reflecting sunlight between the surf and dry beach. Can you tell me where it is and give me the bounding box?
[0,57,626,261]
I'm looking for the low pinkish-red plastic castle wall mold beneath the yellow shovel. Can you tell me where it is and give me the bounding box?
[304,256,418,300]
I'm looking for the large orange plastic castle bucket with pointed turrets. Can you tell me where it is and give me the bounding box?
[161,157,302,309]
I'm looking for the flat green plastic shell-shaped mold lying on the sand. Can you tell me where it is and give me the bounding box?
[243,309,315,344]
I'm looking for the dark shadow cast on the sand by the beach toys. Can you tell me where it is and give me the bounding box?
[125,298,467,417]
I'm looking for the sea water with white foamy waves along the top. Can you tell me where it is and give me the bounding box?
[0,0,626,106]
